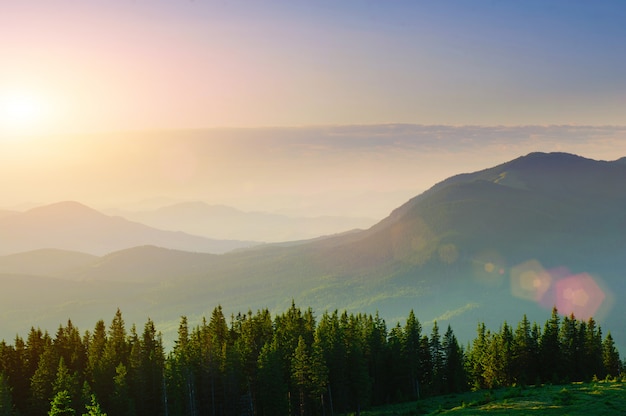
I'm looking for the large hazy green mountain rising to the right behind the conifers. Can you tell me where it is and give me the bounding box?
[0,153,626,352]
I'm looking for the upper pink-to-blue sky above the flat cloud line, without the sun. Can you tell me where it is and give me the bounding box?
[0,0,626,132]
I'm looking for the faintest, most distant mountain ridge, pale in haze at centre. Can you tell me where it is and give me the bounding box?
[106,201,376,242]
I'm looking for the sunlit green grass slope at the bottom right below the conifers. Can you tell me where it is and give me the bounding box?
[344,381,626,416]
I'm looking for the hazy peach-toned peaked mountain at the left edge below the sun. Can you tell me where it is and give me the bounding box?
[0,202,255,255]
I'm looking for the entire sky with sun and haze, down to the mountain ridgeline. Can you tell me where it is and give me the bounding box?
[0,0,626,217]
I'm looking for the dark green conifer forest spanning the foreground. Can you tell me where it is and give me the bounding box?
[0,304,622,416]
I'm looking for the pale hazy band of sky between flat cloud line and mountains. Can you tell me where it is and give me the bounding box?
[0,124,626,219]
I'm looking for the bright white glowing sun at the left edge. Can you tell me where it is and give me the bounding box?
[0,92,47,135]
